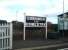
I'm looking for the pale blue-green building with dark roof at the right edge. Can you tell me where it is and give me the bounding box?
[58,12,68,37]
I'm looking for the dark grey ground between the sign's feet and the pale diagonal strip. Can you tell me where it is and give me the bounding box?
[13,39,68,49]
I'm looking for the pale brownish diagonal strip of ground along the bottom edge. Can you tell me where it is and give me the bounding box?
[15,43,68,50]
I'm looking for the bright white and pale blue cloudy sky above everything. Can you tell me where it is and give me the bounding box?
[0,0,68,23]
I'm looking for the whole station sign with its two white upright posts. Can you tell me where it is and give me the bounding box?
[23,13,47,40]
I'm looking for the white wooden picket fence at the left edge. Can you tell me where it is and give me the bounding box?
[0,23,12,50]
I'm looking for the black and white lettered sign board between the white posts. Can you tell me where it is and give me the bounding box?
[26,16,46,27]
